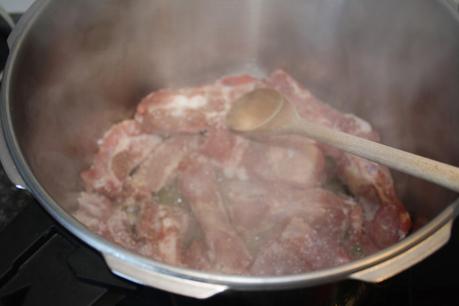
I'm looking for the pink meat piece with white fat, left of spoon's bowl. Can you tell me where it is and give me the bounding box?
[135,75,261,135]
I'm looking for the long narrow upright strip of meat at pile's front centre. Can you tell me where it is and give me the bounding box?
[179,156,251,274]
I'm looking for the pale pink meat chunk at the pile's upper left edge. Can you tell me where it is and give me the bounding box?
[81,120,161,198]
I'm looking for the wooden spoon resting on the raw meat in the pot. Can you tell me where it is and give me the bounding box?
[226,89,459,192]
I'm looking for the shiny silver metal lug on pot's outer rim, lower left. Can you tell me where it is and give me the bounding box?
[103,254,228,299]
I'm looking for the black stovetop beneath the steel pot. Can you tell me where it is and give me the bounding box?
[0,11,459,306]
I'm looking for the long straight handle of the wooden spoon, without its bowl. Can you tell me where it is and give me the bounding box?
[292,119,459,192]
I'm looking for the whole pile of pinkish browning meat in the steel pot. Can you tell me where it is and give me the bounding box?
[75,71,411,275]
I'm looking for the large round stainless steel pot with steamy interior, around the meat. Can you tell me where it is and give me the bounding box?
[0,0,459,298]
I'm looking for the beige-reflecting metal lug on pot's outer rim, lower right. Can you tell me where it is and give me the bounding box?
[349,201,459,283]
